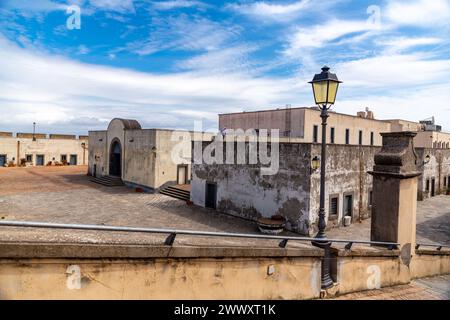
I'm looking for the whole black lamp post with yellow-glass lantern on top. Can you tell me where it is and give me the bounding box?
[309,66,341,289]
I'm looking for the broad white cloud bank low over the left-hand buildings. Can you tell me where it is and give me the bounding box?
[0,37,297,131]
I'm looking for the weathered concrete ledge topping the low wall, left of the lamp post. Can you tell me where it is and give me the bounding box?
[0,242,323,259]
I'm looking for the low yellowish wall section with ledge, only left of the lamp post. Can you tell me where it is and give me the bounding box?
[0,244,322,299]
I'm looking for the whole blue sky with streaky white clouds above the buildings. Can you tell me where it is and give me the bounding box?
[0,0,450,134]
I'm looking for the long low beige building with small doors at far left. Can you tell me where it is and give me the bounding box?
[0,132,88,166]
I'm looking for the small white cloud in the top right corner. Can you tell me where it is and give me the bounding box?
[382,0,450,28]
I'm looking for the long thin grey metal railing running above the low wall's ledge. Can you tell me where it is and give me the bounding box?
[0,221,399,250]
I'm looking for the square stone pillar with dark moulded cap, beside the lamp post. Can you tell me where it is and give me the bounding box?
[369,132,421,264]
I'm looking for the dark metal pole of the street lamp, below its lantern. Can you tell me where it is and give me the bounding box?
[312,105,333,289]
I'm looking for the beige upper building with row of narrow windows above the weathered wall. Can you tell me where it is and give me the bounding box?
[219,107,450,149]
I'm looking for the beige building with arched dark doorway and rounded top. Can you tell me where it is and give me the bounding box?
[89,118,213,192]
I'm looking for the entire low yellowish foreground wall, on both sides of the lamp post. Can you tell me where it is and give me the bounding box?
[0,243,450,299]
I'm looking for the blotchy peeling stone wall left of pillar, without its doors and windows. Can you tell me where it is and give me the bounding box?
[191,143,379,235]
